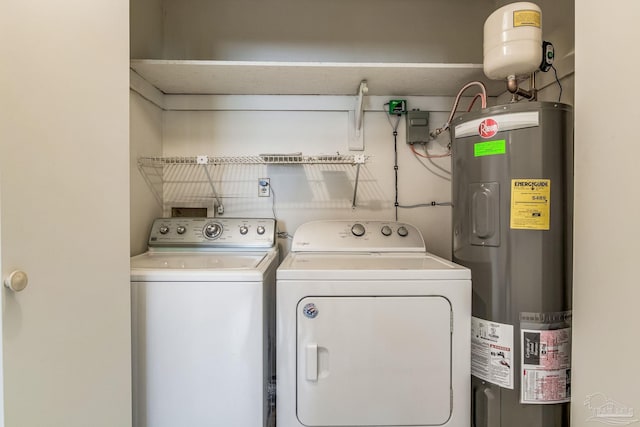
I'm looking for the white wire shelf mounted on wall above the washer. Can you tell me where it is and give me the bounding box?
[138,154,369,167]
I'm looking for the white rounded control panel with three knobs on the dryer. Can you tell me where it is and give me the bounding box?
[291,220,426,252]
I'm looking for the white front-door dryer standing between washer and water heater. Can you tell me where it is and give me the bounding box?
[276,221,471,427]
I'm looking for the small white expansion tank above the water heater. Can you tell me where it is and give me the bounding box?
[484,2,542,80]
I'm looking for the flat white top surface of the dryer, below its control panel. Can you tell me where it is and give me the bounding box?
[277,252,471,280]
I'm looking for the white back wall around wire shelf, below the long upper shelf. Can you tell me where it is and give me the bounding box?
[162,96,470,258]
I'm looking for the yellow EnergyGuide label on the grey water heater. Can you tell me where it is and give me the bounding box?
[511,178,551,230]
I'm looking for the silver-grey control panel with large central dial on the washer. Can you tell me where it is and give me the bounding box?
[149,218,276,249]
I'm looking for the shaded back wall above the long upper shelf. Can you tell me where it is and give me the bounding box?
[164,0,494,63]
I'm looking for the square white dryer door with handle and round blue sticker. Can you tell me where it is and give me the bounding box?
[297,296,452,426]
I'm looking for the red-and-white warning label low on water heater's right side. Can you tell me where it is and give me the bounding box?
[520,328,571,404]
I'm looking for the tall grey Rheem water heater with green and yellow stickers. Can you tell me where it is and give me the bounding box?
[451,102,573,427]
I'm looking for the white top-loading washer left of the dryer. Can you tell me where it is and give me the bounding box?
[131,218,278,427]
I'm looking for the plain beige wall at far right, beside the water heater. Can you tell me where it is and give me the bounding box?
[572,0,640,426]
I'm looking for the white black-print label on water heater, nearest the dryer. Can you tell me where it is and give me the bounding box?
[471,317,514,390]
